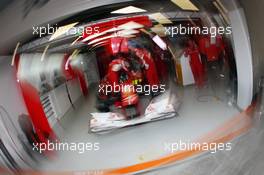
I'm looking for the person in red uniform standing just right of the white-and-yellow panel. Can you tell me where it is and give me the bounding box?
[184,39,205,88]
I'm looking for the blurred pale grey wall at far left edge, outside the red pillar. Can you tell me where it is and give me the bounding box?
[0,56,34,168]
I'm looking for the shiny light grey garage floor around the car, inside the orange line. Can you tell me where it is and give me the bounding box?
[39,80,239,172]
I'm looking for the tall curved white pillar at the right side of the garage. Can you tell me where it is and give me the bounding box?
[229,8,253,109]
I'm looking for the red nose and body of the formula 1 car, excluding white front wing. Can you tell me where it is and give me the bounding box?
[97,57,142,118]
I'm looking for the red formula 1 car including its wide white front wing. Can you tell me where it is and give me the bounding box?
[90,53,180,133]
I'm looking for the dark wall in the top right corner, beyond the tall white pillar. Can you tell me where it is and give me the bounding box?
[240,0,264,92]
